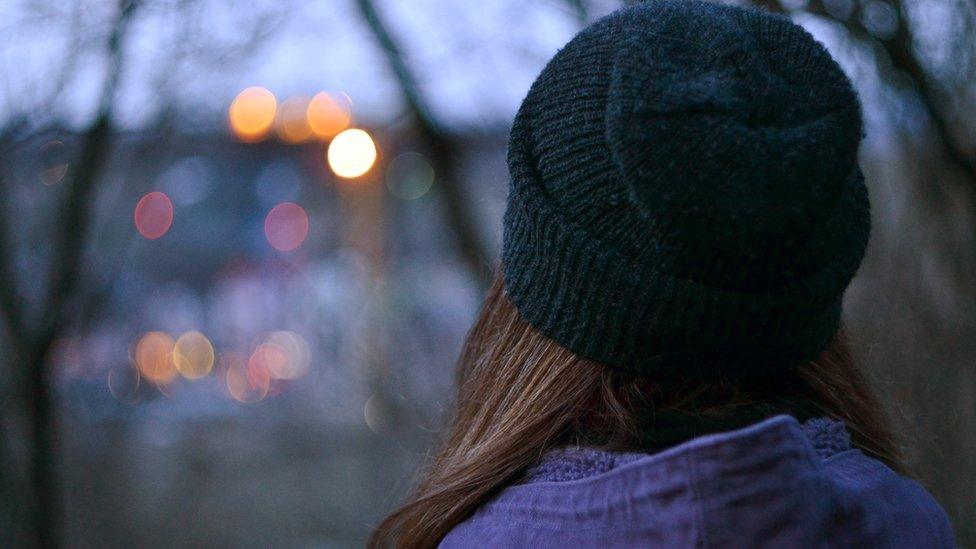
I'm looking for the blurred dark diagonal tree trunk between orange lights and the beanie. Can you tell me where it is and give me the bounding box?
[356,0,491,283]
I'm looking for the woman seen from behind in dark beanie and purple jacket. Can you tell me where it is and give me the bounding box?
[372,0,953,547]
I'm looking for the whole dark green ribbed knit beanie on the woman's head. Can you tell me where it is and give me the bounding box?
[503,0,870,375]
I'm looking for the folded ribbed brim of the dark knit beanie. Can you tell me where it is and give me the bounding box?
[502,106,870,375]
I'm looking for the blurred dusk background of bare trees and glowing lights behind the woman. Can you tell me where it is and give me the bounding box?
[0,0,976,547]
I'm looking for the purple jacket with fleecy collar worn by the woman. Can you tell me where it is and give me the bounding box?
[441,415,954,549]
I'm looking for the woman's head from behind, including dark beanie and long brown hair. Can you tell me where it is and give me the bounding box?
[372,0,897,547]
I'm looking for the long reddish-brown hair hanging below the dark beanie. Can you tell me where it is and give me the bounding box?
[369,276,903,548]
